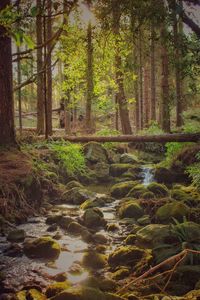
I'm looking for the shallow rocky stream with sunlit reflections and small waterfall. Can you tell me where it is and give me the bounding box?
[0,166,153,292]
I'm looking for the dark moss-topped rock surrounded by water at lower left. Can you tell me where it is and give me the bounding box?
[24,237,61,260]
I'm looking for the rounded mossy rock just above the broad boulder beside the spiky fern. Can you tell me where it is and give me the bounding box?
[156,201,190,223]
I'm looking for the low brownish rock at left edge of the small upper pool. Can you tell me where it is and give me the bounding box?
[62,187,95,205]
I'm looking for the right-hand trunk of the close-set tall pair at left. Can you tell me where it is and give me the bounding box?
[46,0,52,135]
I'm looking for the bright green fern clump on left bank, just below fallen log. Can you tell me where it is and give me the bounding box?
[49,142,85,175]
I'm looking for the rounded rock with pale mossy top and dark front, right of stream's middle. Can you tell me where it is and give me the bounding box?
[118,199,144,220]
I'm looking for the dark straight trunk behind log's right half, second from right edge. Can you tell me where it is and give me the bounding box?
[161,25,170,132]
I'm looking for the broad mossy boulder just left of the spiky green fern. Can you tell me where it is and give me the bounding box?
[136,224,177,248]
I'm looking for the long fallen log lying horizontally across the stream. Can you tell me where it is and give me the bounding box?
[51,133,200,144]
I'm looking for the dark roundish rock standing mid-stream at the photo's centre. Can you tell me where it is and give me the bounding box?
[83,207,106,228]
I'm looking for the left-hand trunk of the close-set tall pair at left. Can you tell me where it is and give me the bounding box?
[36,0,44,134]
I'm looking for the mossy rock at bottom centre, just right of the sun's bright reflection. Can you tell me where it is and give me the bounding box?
[82,251,107,270]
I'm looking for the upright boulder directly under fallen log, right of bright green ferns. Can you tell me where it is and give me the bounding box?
[83,142,109,164]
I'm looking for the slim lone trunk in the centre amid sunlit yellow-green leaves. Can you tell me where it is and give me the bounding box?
[86,23,94,132]
